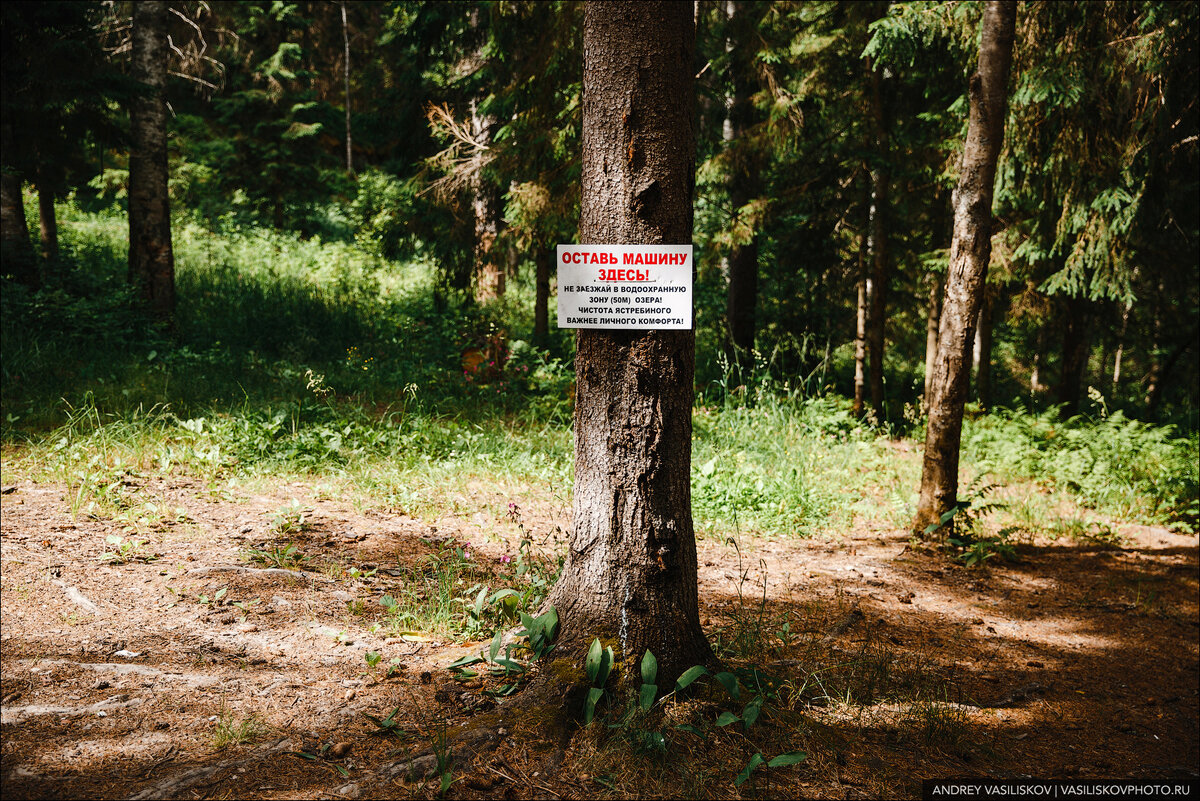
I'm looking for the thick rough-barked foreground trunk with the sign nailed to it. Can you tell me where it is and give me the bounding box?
[551,0,710,687]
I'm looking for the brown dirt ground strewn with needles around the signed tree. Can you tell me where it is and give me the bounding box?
[0,462,1200,799]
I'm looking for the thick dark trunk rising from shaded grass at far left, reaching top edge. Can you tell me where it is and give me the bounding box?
[130,0,175,321]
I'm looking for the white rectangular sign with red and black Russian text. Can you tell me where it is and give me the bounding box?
[557,245,692,330]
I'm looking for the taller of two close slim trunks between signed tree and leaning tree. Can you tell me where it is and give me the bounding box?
[866,56,892,422]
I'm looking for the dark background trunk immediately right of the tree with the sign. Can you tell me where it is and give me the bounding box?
[726,1,758,365]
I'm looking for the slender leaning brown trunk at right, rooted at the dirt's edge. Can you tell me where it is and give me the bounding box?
[913,0,1016,536]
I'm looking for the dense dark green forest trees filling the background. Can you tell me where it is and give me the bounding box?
[4,0,1200,424]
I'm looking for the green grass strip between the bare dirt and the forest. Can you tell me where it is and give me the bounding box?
[0,204,1200,553]
